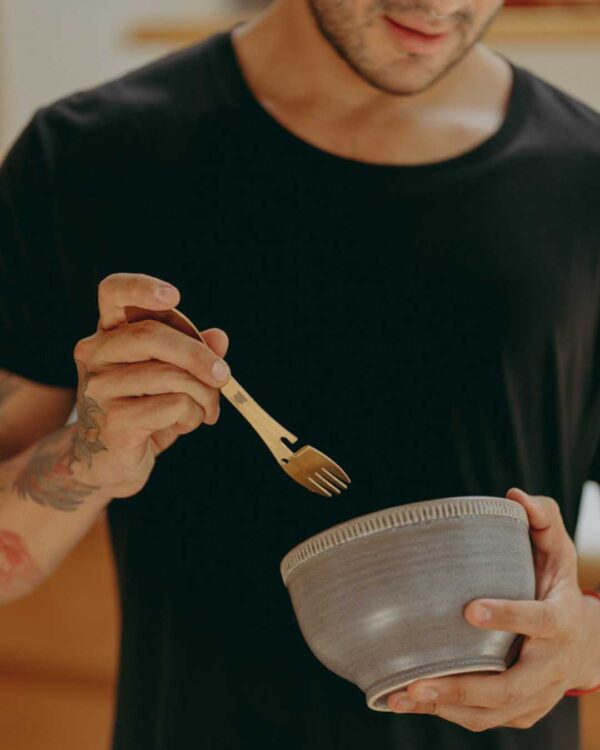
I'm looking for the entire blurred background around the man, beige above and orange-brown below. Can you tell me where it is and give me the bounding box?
[0,0,600,750]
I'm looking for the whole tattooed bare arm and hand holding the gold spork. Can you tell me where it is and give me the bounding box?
[0,273,230,604]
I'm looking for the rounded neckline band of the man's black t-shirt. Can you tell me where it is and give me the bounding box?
[218,27,528,177]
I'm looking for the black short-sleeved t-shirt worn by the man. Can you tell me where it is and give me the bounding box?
[0,27,600,750]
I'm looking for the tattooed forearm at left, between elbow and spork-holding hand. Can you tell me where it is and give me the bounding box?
[0,425,111,604]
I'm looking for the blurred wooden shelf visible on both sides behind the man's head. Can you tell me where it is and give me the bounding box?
[127,3,600,46]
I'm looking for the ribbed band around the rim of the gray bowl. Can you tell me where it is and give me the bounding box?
[280,497,529,585]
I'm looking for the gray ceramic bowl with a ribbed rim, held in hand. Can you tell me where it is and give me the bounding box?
[281,497,535,711]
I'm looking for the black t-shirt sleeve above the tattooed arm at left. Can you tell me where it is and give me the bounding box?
[0,111,77,394]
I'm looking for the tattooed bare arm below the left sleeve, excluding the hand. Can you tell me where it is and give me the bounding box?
[0,371,110,604]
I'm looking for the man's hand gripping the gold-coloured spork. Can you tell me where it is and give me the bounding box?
[69,273,230,497]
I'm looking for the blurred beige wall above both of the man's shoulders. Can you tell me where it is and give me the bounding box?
[0,0,600,153]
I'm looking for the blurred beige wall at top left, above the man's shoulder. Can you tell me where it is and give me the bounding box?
[0,0,230,153]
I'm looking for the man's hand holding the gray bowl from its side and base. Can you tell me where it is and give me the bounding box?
[387,488,600,732]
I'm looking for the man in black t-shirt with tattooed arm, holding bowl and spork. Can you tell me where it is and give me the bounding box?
[0,0,600,750]
